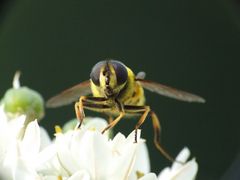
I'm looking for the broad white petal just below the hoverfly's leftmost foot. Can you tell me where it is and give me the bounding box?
[70,130,111,179]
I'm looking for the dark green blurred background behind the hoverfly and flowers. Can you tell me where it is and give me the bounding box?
[0,0,240,180]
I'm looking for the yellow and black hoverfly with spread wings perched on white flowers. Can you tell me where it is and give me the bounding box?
[47,60,205,162]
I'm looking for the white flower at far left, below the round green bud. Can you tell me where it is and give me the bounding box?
[0,106,49,180]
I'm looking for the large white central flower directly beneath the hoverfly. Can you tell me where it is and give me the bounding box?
[38,117,149,180]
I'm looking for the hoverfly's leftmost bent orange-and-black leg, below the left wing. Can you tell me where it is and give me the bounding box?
[75,96,107,128]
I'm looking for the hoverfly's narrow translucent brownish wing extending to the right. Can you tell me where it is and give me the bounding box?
[136,79,205,103]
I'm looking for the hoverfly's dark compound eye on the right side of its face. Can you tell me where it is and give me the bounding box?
[111,61,128,85]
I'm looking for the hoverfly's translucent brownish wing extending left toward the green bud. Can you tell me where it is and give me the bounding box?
[46,80,91,108]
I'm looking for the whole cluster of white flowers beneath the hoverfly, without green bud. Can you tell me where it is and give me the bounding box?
[0,73,198,180]
